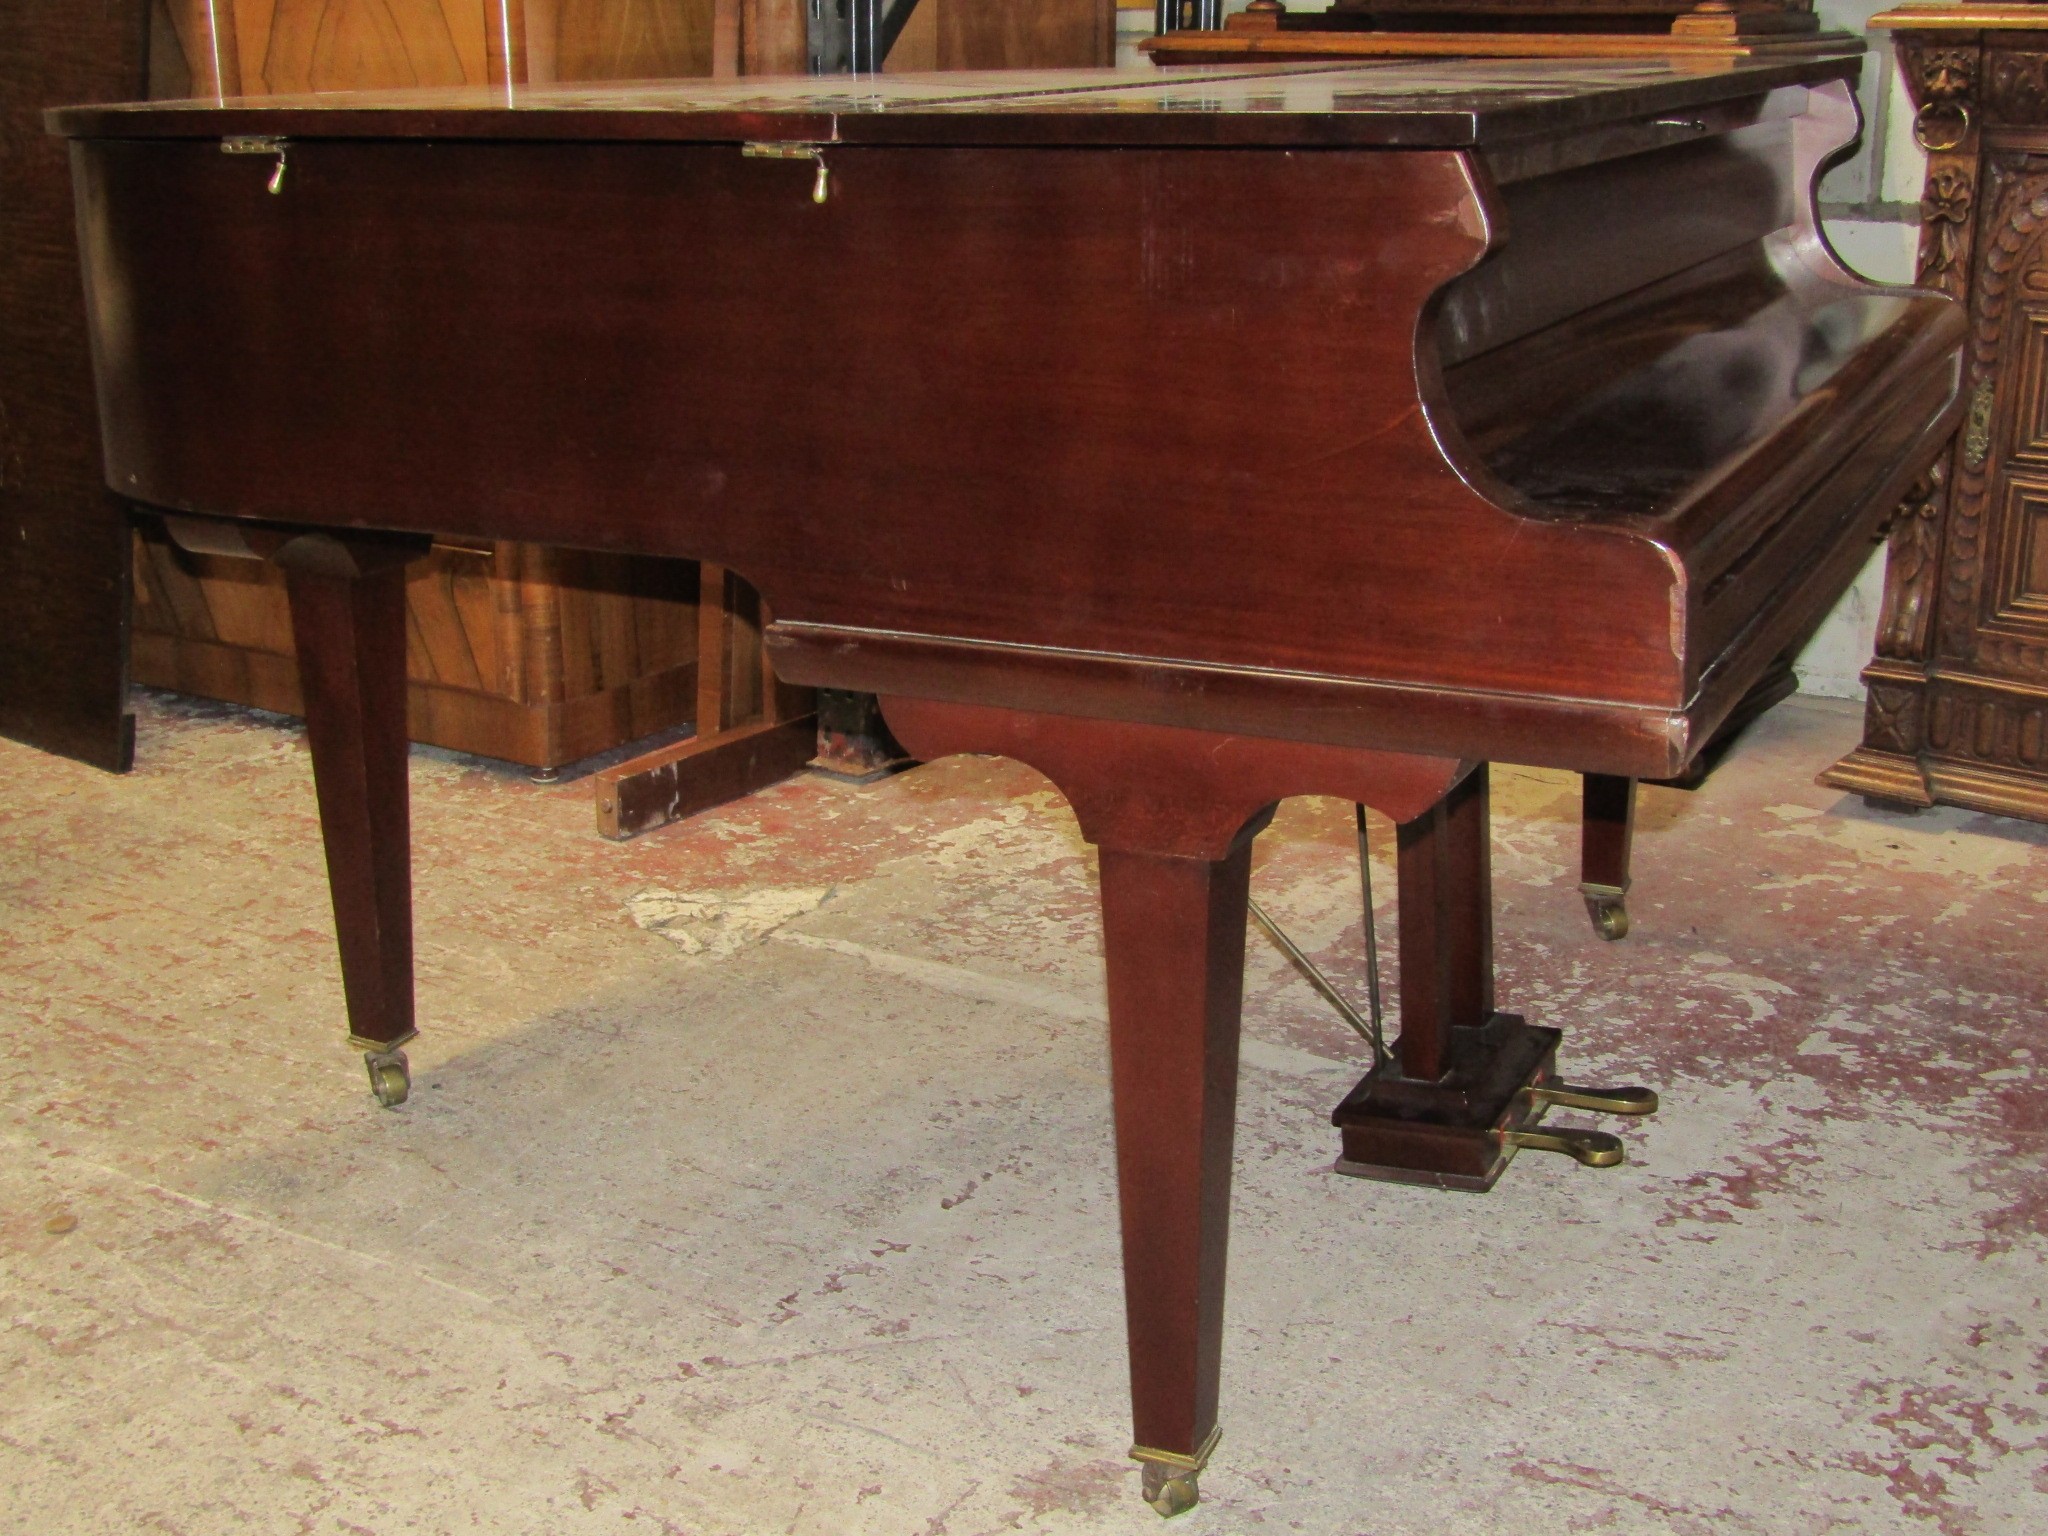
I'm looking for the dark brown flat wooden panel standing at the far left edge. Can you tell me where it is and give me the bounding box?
[0,0,145,770]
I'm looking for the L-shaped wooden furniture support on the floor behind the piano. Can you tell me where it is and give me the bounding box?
[596,565,817,840]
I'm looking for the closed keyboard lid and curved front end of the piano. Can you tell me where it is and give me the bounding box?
[1423,82,1962,772]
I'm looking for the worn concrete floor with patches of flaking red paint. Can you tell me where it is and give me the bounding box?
[0,696,2048,1536]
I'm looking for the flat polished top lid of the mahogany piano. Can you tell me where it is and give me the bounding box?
[49,49,1862,147]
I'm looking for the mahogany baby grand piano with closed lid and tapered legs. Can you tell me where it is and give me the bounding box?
[53,57,1962,1513]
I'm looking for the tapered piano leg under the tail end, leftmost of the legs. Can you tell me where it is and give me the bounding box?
[270,535,418,1108]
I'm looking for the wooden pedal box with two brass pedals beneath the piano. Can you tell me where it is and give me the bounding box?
[1329,1028,1657,1194]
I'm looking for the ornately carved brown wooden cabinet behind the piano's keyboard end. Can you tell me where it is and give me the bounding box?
[1821,4,2048,821]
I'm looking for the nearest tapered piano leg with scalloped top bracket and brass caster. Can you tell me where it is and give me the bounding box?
[883,698,1464,1516]
